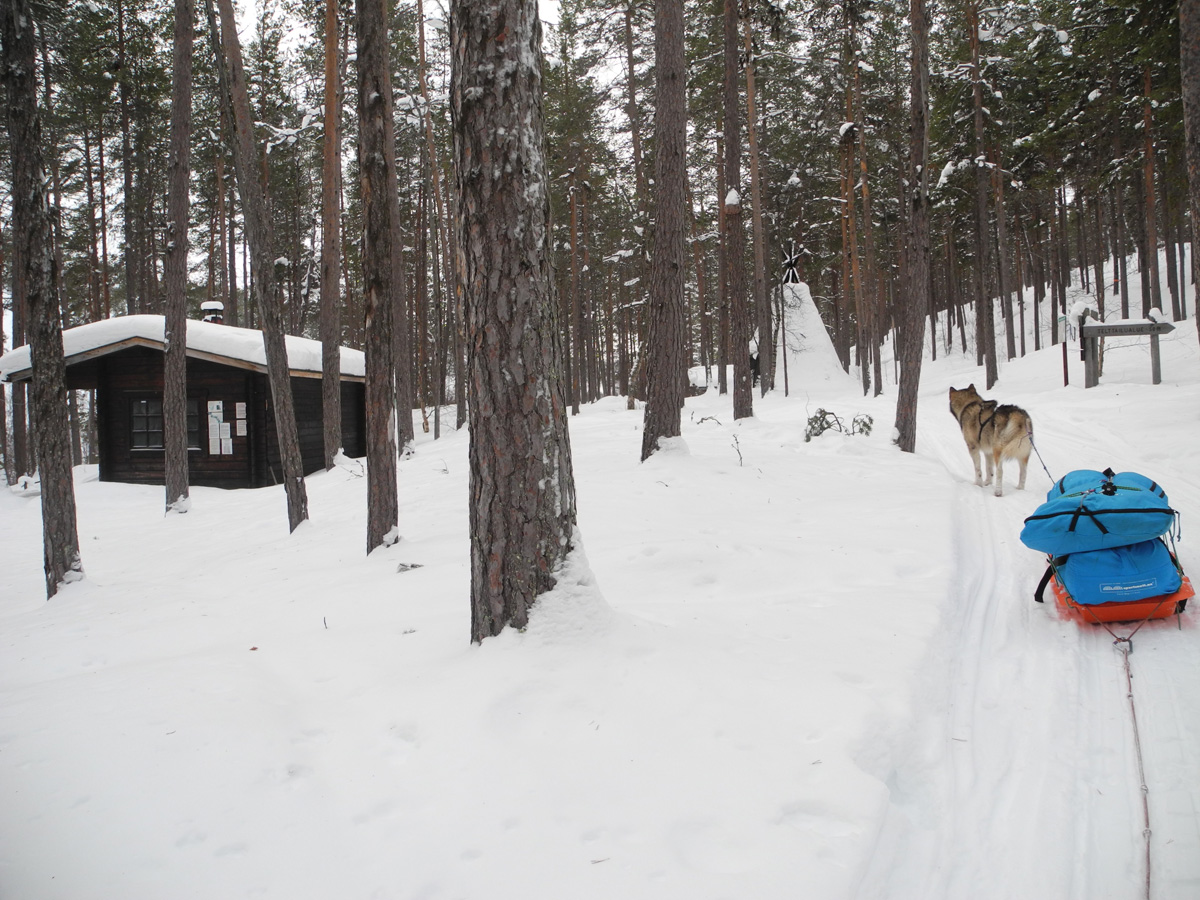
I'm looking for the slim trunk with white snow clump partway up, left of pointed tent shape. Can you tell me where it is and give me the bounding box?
[724,0,754,419]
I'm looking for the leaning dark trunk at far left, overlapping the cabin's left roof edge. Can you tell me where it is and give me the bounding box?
[0,0,83,599]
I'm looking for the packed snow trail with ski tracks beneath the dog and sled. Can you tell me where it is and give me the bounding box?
[860,386,1200,900]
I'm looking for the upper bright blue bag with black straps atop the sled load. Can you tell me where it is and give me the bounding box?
[1021,469,1177,557]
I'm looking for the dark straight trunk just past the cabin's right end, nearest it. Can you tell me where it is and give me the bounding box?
[355,0,400,553]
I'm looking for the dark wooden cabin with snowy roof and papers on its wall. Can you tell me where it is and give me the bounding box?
[0,316,366,487]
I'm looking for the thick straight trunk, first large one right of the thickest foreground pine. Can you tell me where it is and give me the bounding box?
[642,0,689,462]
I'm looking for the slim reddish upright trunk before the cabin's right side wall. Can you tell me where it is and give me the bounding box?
[320,0,342,470]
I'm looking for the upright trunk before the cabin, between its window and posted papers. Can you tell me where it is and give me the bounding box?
[162,0,196,512]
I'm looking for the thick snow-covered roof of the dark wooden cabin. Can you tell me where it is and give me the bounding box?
[0,316,366,382]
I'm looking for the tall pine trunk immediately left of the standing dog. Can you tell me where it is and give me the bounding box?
[895,0,932,454]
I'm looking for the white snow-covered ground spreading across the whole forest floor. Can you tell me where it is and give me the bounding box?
[0,262,1200,900]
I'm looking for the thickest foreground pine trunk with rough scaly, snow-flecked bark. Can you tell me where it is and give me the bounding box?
[450,0,576,642]
